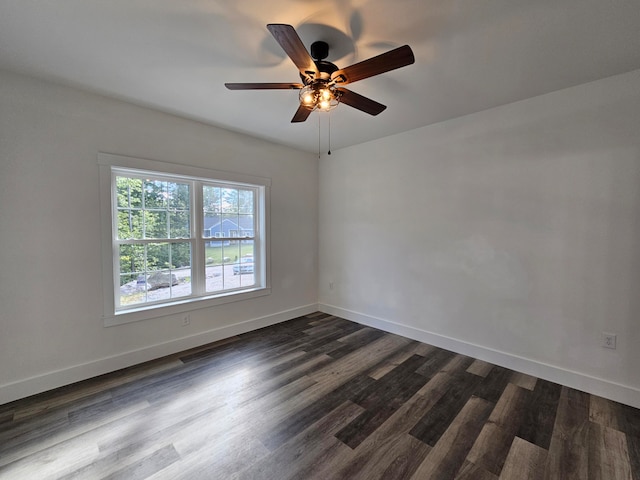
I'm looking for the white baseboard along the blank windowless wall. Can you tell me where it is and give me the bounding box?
[318,303,640,408]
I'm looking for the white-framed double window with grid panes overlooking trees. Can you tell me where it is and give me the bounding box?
[99,154,268,324]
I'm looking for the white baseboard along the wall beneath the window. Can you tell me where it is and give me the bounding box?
[0,303,318,405]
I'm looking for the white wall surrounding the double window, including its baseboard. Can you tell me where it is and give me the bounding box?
[0,72,318,404]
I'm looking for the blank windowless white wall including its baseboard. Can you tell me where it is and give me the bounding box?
[319,71,640,407]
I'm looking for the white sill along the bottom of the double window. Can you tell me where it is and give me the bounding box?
[102,288,271,327]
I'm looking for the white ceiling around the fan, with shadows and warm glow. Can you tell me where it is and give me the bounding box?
[0,0,640,152]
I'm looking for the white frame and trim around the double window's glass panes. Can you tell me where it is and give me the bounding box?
[98,153,271,326]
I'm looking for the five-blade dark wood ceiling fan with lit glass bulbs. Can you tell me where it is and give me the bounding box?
[225,23,415,123]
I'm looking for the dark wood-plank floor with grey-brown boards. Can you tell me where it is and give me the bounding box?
[0,313,640,480]
